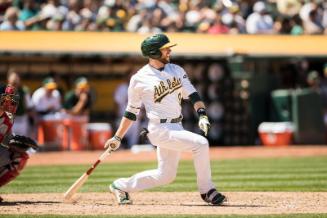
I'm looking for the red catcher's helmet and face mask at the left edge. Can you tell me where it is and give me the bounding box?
[0,86,19,114]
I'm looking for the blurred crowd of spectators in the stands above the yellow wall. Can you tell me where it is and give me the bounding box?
[0,0,327,35]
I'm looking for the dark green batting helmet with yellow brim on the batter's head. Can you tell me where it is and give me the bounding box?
[141,33,176,59]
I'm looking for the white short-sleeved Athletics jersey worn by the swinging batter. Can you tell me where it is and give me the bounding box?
[126,64,196,120]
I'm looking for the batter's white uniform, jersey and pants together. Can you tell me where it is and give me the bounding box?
[114,64,218,194]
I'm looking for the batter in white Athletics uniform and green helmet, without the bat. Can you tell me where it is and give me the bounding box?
[105,34,226,205]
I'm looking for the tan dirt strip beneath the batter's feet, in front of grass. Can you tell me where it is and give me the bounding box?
[0,192,327,215]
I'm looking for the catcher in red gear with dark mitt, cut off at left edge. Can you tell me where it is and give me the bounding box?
[0,86,38,202]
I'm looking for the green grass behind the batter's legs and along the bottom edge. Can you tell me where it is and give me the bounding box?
[0,156,327,218]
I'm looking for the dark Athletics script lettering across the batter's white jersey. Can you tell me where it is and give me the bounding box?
[154,77,182,103]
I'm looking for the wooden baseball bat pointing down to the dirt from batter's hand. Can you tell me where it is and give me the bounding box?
[64,147,111,200]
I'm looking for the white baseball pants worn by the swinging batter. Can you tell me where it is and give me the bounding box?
[114,122,214,194]
